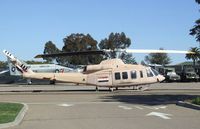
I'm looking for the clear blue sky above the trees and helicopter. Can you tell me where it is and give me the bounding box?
[0,0,200,64]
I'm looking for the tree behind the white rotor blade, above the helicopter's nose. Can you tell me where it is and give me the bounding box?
[145,48,171,66]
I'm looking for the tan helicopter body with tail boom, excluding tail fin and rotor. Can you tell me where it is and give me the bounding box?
[23,59,165,87]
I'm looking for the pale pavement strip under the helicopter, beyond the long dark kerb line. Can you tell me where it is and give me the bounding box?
[0,82,200,92]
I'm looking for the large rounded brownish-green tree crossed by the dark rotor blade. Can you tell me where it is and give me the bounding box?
[62,33,102,65]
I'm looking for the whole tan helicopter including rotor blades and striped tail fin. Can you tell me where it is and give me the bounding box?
[4,50,192,90]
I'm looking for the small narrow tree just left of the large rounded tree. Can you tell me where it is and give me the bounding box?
[43,41,60,63]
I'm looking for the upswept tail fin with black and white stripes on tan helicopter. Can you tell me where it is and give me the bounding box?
[3,50,33,74]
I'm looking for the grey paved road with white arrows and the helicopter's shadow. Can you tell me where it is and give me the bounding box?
[0,83,200,129]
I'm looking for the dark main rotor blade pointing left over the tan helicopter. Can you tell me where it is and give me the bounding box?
[35,50,105,58]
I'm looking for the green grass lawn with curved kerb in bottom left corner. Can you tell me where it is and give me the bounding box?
[0,102,23,124]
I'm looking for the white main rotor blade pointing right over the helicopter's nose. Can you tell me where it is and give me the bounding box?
[124,49,195,54]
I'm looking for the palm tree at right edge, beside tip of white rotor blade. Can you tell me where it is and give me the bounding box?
[185,47,200,67]
